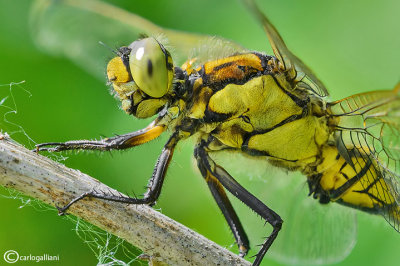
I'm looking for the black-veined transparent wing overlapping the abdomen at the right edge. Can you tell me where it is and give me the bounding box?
[330,84,400,231]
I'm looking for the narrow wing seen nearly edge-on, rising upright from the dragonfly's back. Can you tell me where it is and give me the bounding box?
[243,0,329,97]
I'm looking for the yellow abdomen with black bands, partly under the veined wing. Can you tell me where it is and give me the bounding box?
[308,146,400,223]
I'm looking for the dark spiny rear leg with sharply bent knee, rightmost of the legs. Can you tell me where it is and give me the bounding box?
[196,140,283,265]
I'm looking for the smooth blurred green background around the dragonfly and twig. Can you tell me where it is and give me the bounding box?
[0,0,400,265]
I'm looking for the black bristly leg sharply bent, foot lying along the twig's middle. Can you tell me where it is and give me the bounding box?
[58,133,179,215]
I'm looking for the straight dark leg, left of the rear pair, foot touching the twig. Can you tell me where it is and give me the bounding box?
[195,149,250,257]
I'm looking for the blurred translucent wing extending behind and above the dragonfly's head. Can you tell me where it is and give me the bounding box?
[30,0,244,79]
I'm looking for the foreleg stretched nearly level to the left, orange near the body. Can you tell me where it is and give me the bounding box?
[34,120,165,152]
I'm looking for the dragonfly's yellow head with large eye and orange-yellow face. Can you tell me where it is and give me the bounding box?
[107,37,174,118]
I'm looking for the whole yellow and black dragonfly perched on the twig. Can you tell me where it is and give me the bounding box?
[35,1,400,265]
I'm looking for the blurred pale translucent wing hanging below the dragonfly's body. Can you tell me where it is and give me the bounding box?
[215,152,357,265]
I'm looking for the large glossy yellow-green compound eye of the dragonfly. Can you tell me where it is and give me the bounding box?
[129,38,173,98]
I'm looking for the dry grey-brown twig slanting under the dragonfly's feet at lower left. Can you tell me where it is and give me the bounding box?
[0,135,250,265]
